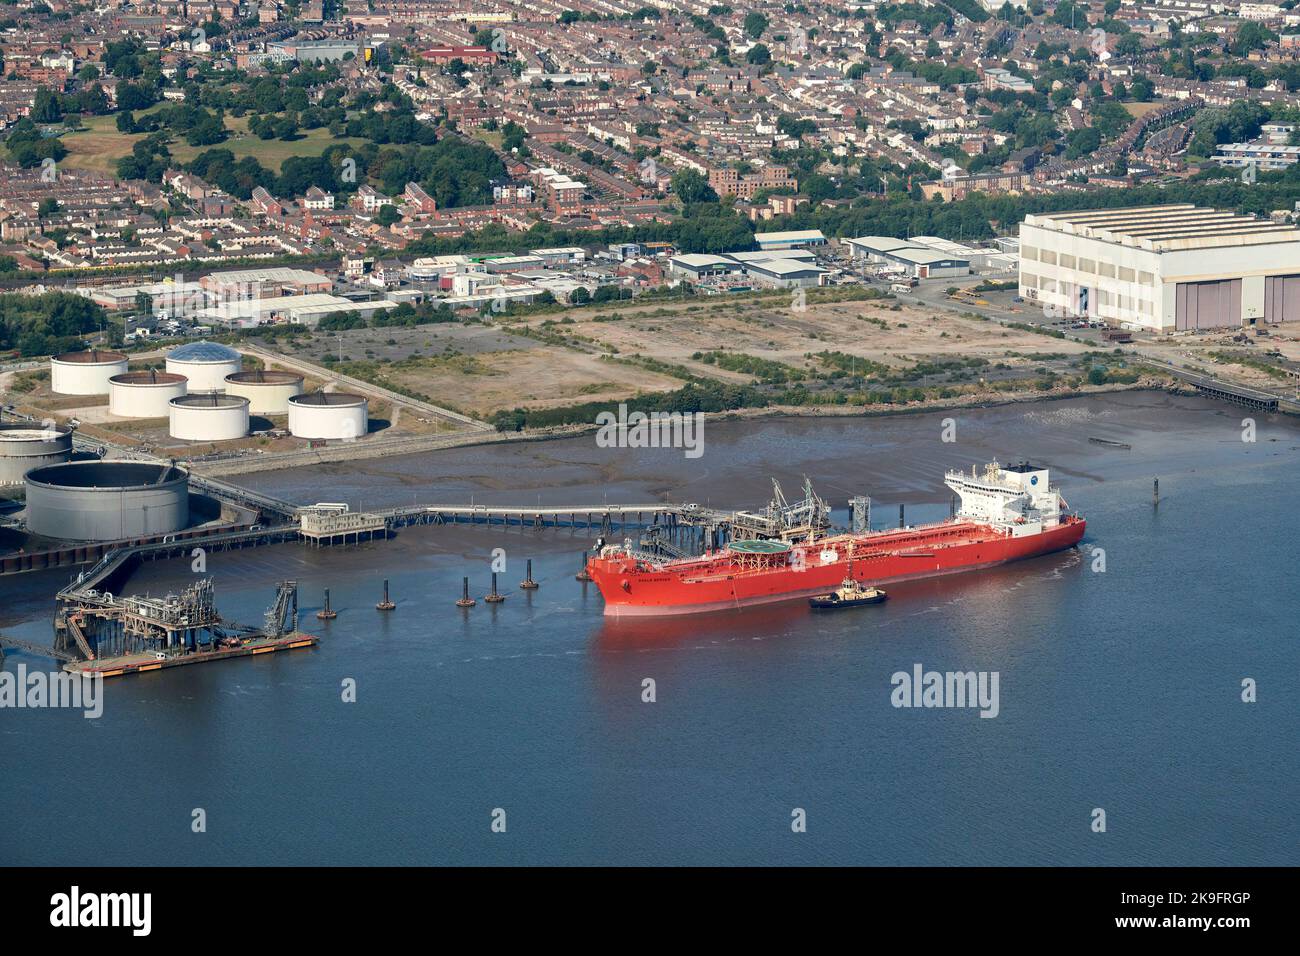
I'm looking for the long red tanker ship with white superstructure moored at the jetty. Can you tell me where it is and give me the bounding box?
[586,462,1086,617]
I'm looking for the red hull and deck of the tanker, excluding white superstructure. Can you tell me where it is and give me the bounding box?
[588,518,1086,617]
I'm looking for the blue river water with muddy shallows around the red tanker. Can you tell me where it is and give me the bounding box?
[0,393,1300,865]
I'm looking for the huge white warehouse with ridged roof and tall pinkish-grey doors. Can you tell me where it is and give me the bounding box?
[1019,204,1300,332]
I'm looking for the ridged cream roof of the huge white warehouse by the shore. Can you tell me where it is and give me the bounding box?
[1024,203,1300,252]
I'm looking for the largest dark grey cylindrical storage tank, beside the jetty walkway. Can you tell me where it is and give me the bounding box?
[25,462,190,541]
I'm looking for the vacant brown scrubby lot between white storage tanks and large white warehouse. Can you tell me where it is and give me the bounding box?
[250,290,1128,419]
